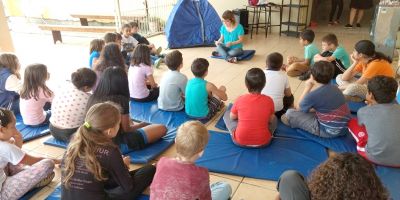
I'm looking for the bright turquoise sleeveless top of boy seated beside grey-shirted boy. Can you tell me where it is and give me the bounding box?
[185,78,209,118]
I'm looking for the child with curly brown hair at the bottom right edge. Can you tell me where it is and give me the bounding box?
[276,153,388,200]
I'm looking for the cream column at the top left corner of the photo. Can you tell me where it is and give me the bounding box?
[0,0,14,52]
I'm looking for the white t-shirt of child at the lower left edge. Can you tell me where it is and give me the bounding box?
[0,141,25,191]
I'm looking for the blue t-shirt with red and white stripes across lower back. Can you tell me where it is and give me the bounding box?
[300,84,350,136]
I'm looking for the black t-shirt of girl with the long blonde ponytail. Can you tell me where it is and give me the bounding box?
[61,146,134,200]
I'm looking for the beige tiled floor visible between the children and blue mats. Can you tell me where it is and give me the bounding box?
[12,23,396,200]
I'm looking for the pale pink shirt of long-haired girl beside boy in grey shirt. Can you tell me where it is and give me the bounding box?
[128,63,153,99]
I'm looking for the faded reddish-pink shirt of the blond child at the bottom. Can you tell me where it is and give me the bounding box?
[150,157,211,200]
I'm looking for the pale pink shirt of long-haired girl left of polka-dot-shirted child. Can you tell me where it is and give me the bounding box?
[19,88,53,125]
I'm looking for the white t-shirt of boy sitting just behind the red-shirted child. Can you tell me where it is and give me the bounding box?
[261,70,290,112]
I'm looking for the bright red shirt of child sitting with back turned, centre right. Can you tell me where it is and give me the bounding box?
[231,94,275,145]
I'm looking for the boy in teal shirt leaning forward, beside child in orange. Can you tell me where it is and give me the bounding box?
[314,33,350,78]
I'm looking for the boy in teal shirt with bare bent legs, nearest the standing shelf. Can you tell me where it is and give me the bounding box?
[286,30,319,77]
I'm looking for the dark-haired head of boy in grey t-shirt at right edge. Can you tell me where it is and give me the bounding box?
[367,75,398,104]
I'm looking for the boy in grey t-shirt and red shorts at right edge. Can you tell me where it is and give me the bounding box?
[349,75,400,167]
